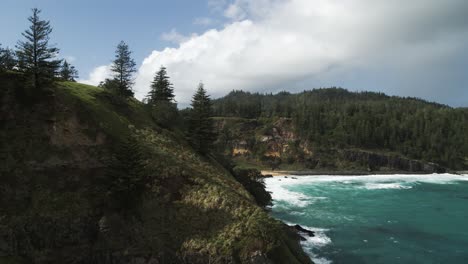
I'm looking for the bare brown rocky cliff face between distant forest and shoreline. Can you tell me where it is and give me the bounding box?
[218,118,445,173]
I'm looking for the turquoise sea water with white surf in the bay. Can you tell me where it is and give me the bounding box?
[265,174,468,264]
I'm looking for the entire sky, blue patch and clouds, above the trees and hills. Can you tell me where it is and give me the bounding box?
[0,0,468,107]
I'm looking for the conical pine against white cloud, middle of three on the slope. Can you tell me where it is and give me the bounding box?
[147,66,175,105]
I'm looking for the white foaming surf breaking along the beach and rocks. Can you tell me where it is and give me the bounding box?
[264,174,468,264]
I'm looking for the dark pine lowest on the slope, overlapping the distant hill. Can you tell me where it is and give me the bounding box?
[189,83,216,154]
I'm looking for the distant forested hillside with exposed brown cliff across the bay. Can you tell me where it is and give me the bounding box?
[214,88,468,172]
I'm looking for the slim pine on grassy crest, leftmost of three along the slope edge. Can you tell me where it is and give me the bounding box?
[111,41,136,97]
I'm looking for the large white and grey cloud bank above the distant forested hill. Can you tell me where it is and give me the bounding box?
[83,0,468,105]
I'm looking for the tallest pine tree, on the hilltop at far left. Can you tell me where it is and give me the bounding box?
[17,8,61,88]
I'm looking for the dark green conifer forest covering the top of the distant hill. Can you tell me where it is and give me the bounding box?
[213,88,468,168]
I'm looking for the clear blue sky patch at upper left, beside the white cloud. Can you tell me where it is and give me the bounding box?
[0,0,218,77]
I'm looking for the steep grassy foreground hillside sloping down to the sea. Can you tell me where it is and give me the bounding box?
[0,71,310,263]
